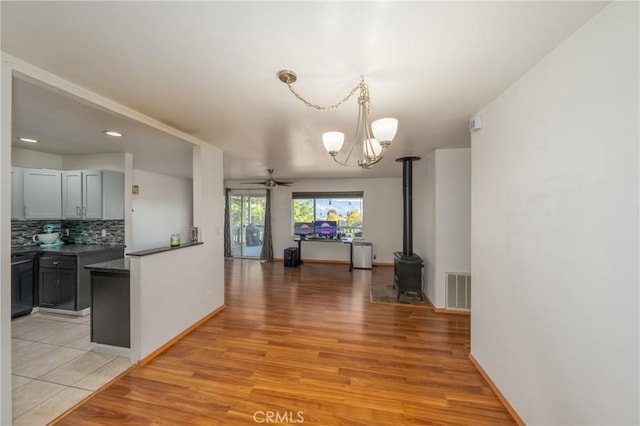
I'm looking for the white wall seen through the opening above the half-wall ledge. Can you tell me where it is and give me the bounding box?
[127,169,193,252]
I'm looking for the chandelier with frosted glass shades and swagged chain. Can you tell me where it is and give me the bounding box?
[278,70,398,169]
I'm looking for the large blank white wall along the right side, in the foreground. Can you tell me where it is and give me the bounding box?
[471,2,640,425]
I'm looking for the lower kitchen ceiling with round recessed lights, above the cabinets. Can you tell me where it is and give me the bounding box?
[12,76,193,178]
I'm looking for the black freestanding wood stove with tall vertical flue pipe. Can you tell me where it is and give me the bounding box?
[393,157,424,300]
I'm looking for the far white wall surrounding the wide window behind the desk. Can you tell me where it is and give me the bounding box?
[271,176,402,263]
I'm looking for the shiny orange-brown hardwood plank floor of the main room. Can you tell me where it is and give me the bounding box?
[59,260,515,426]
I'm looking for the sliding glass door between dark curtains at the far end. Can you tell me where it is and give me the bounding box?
[230,191,266,258]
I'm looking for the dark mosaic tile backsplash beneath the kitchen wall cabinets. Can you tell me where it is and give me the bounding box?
[11,220,124,246]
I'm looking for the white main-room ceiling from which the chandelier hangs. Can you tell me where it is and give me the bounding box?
[0,1,606,180]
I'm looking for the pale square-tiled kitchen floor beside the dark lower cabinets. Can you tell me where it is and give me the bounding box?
[11,312,131,426]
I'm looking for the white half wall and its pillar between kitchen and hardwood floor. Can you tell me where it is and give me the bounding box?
[131,145,224,361]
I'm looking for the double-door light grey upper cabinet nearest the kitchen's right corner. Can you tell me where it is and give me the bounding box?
[62,170,124,220]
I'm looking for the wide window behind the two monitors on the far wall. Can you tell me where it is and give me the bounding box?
[291,192,364,237]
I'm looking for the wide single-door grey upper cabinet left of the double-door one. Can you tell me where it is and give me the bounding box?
[22,169,62,219]
